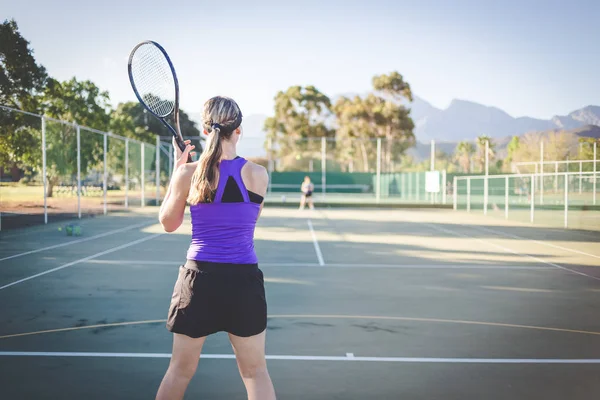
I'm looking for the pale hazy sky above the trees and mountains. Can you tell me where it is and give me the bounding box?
[0,0,600,118]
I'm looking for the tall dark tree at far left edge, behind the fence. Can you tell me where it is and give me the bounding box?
[0,20,47,168]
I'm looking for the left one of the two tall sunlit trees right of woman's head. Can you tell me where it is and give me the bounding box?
[264,86,335,170]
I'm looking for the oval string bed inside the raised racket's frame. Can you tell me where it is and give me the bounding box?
[131,43,175,117]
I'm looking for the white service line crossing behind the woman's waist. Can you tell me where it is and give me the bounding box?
[84,260,556,271]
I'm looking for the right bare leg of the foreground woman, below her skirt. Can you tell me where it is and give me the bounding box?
[229,330,275,400]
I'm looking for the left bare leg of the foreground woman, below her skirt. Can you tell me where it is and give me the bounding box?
[156,333,206,400]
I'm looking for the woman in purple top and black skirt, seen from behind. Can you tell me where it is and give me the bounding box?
[156,97,275,400]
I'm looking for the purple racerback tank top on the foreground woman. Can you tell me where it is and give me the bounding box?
[187,157,260,264]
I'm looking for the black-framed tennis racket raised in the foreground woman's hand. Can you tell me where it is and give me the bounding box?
[127,40,192,162]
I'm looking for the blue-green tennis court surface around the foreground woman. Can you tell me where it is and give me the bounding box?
[0,208,600,400]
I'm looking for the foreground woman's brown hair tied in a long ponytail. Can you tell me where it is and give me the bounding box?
[187,96,242,205]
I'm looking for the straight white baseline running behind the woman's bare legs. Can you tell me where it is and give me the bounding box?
[0,351,600,364]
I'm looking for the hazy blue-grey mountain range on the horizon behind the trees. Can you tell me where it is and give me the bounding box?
[190,99,600,158]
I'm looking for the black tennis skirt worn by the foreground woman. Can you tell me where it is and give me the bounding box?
[167,260,267,338]
